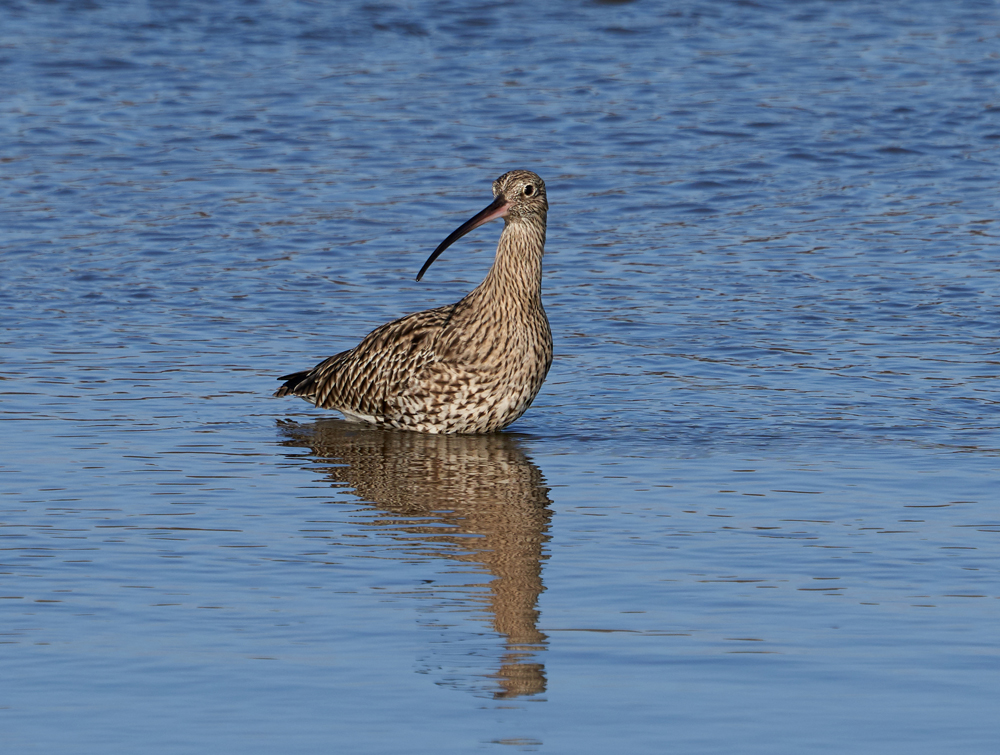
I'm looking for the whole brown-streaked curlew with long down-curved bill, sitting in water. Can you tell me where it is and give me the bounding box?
[274,170,552,433]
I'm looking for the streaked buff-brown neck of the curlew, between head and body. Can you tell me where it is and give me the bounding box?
[477,214,545,305]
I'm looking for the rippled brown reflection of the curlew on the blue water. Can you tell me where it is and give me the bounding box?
[281,419,551,697]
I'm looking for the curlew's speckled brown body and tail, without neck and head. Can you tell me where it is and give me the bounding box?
[275,292,552,433]
